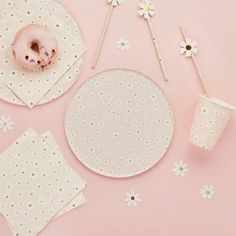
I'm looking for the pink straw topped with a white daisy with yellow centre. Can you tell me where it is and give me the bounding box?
[138,0,168,81]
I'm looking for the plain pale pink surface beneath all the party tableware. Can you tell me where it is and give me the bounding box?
[0,0,236,236]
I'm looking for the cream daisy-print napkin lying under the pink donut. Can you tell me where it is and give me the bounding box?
[0,0,85,107]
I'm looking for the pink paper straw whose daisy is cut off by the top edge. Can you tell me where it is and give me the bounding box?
[92,0,123,69]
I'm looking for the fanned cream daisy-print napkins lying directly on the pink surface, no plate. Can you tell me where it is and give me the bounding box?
[0,130,86,236]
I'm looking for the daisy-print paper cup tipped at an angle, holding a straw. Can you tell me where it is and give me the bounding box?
[190,95,235,150]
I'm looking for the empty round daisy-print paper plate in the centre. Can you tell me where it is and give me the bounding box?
[65,69,174,178]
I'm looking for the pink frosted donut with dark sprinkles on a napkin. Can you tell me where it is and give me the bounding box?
[13,25,58,71]
